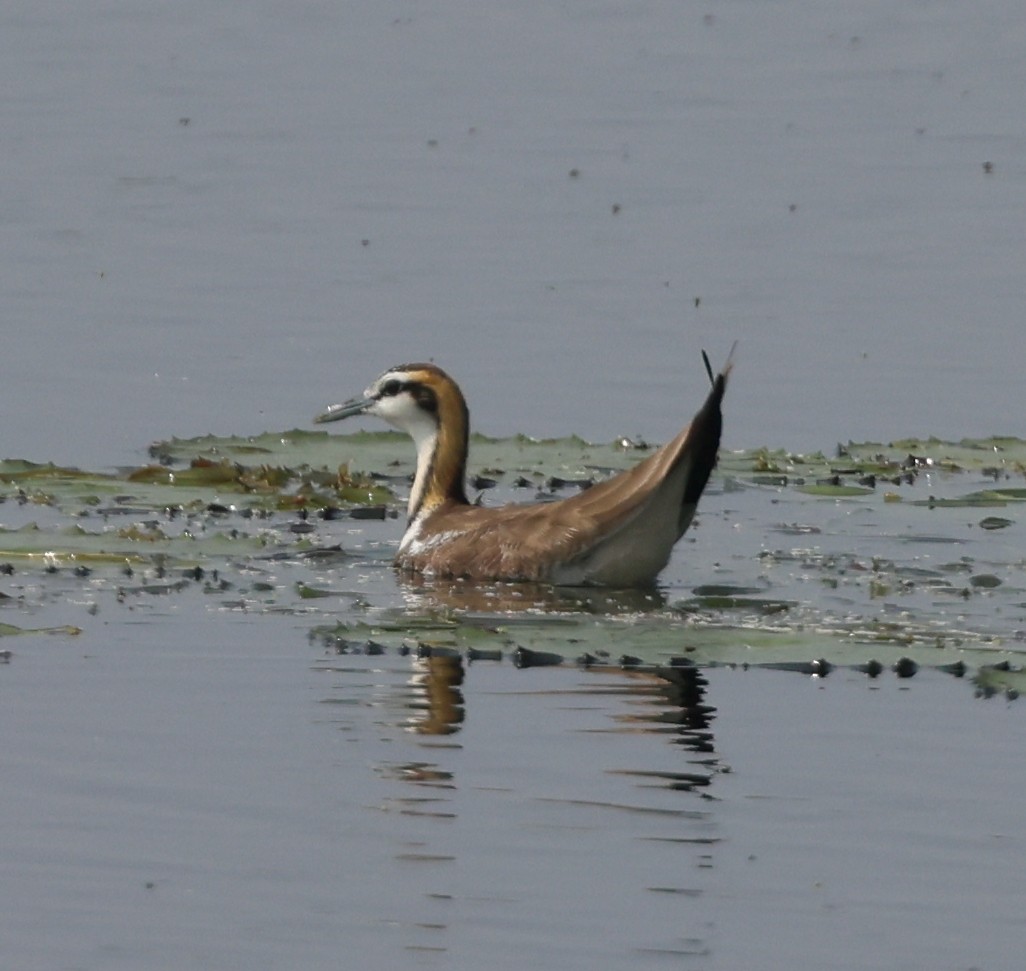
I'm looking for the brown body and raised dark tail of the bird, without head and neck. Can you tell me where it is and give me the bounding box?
[399,364,729,586]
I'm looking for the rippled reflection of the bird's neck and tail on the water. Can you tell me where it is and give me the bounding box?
[334,628,721,954]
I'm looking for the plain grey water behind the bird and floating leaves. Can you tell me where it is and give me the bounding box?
[0,0,1026,466]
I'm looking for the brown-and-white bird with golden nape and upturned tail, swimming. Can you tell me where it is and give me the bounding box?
[314,349,734,588]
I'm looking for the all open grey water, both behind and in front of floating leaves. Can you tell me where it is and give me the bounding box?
[0,0,1026,971]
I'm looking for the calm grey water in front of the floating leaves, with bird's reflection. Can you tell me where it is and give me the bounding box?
[0,606,1026,969]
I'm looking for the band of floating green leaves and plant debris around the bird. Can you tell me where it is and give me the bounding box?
[0,429,1026,691]
